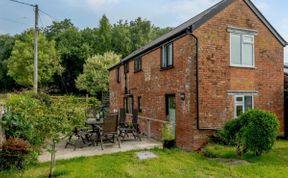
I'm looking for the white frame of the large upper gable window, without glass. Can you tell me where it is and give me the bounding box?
[230,32,255,68]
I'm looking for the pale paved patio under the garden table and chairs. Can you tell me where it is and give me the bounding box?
[38,137,162,162]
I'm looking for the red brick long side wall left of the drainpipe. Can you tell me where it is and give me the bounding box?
[110,36,195,149]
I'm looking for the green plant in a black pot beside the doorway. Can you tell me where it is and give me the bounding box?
[162,122,176,149]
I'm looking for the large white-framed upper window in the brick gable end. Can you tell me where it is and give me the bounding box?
[230,33,255,67]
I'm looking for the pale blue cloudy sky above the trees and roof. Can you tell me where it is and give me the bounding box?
[0,0,288,63]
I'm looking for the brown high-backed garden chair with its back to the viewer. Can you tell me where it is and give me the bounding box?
[97,113,120,150]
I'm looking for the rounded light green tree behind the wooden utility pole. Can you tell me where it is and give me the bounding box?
[7,30,63,86]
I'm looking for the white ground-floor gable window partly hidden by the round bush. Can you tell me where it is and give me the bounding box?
[234,95,254,118]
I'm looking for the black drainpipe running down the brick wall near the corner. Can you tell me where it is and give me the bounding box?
[187,26,219,131]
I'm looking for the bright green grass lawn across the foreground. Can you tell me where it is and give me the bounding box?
[0,141,288,178]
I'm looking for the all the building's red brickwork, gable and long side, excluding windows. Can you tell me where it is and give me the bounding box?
[110,0,284,150]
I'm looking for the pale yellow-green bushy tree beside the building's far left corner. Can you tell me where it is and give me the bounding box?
[76,52,120,95]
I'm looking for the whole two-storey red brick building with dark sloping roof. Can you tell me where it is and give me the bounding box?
[109,0,287,150]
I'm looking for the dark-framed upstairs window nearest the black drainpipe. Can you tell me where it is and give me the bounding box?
[161,43,173,69]
